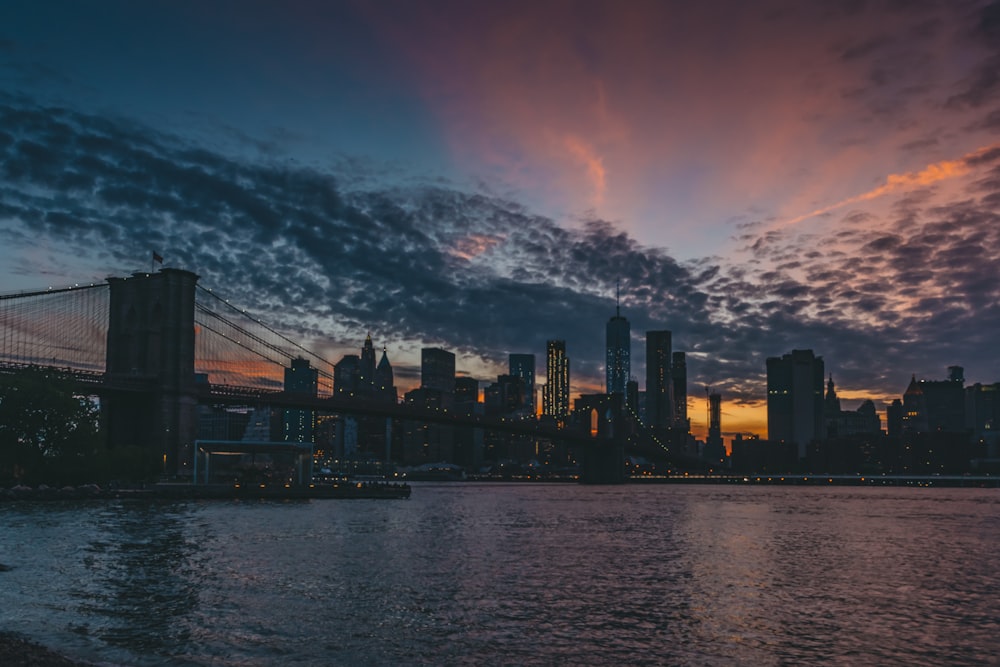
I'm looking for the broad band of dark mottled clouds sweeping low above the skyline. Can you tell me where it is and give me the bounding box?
[0,99,1000,434]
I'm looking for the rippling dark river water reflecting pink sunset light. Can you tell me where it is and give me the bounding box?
[0,484,1000,665]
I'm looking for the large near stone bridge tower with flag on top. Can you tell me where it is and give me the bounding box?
[101,268,198,474]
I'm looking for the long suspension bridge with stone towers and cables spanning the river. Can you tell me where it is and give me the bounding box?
[0,268,680,481]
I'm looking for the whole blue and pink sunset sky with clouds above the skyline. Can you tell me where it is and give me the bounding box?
[0,0,1000,435]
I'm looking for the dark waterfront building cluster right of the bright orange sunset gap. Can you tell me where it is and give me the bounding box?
[732,350,1000,475]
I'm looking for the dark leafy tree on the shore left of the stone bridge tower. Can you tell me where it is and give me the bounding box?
[0,367,100,484]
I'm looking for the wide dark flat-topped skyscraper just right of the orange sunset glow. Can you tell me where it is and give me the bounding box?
[767,350,825,459]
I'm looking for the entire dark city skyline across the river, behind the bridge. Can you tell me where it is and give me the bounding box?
[201,305,1000,474]
